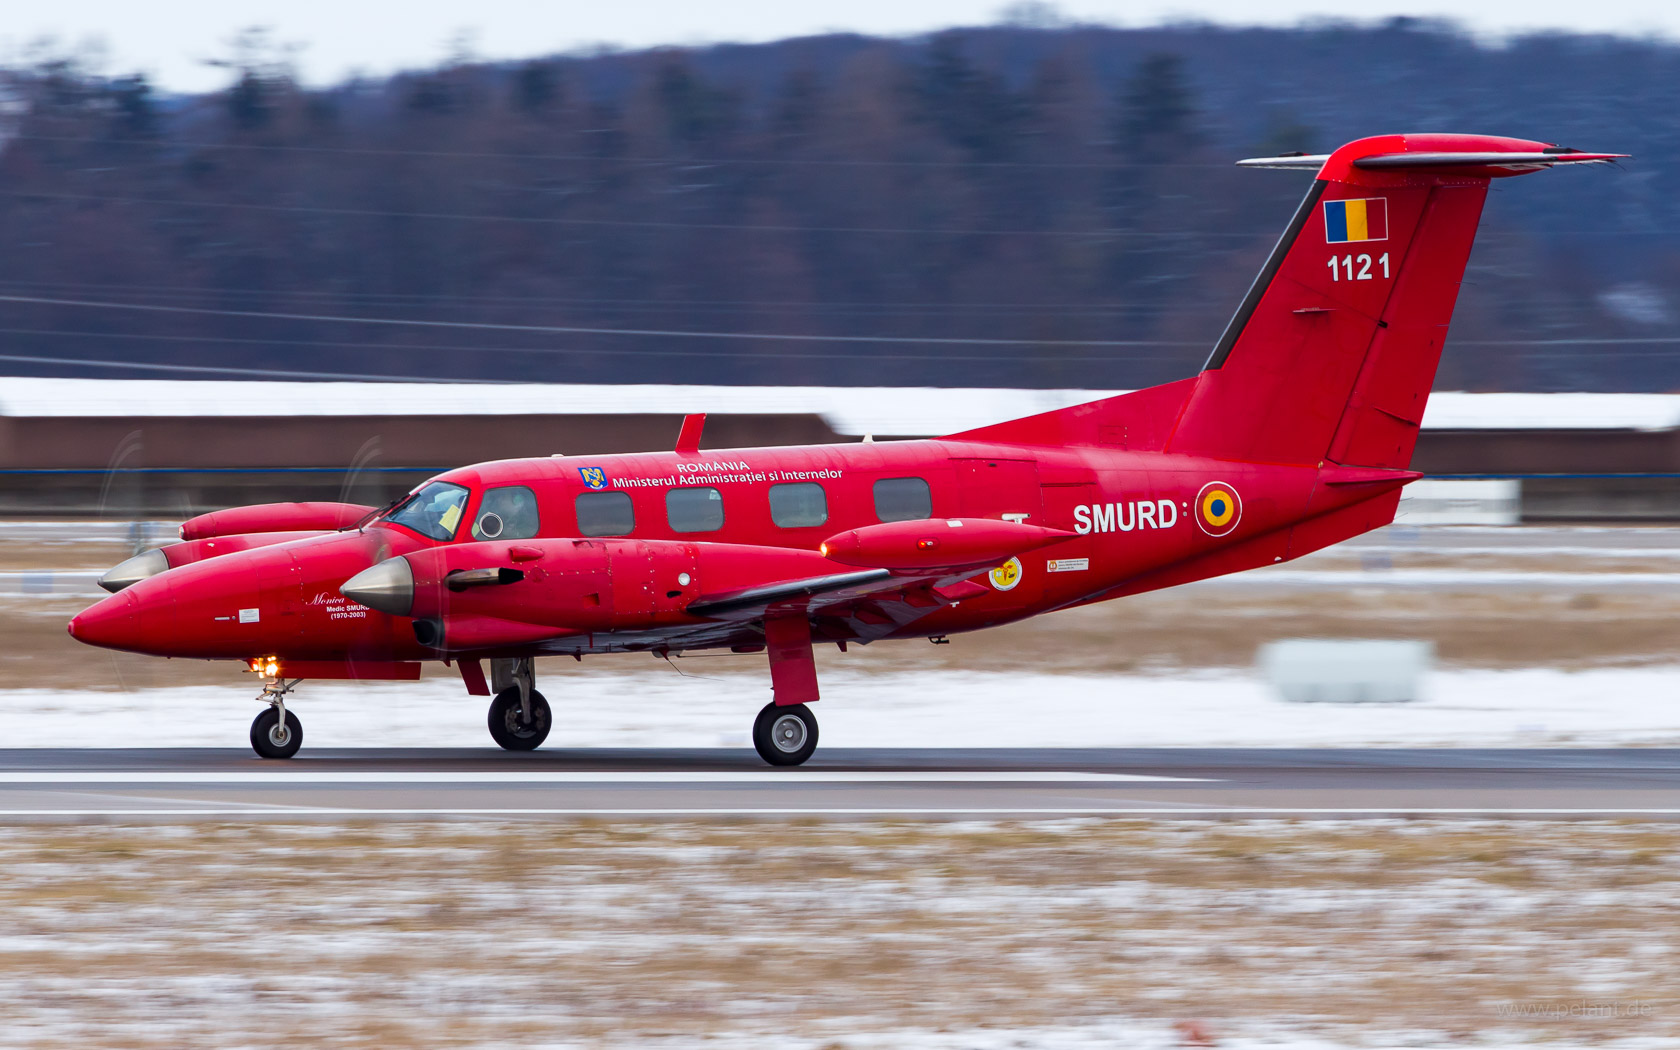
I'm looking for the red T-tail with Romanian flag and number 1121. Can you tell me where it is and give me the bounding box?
[961,134,1621,470]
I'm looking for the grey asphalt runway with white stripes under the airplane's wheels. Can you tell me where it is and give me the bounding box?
[0,748,1680,822]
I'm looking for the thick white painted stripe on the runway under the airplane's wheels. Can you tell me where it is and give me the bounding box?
[0,768,1206,786]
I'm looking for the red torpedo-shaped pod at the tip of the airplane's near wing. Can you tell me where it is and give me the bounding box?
[822,517,1075,571]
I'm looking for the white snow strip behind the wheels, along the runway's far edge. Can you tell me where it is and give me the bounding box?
[0,660,1680,748]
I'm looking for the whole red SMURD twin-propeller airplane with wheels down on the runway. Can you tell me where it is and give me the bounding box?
[69,134,1623,766]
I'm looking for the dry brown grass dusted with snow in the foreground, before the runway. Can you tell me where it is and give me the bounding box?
[0,820,1680,1048]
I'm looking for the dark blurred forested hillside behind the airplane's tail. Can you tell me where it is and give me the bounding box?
[0,22,1680,390]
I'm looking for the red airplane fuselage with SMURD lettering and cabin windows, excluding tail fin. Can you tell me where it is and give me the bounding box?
[72,440,1377,662]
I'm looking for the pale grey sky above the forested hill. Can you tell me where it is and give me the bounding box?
[0,0,1680,91]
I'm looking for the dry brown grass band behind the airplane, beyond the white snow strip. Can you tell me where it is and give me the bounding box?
[22,527,1680,689]
